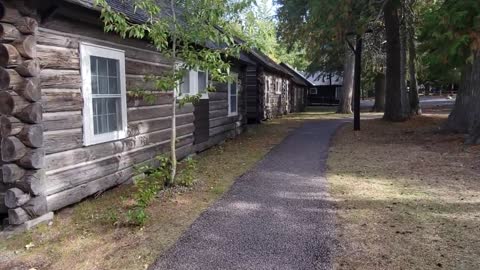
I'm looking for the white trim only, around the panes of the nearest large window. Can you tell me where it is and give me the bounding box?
[80,42,128,146]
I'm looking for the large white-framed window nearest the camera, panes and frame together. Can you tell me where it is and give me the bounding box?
[80,42,127,145]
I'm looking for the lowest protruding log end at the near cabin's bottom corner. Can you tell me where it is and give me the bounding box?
[8,196,47,225]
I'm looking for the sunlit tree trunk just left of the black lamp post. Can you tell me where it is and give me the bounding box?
[337,48,355,114]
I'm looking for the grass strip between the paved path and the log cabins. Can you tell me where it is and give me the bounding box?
[0,110,342,270]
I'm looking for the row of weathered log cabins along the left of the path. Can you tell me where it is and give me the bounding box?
[0,0,309,228]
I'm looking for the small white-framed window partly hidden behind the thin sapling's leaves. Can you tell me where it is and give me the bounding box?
[179,70,208,99]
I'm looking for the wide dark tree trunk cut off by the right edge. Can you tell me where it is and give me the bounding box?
[446,52,480,144]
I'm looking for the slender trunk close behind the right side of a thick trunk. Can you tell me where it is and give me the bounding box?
[408,22,422,115]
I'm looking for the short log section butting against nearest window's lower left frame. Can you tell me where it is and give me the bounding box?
[44,129,83,154]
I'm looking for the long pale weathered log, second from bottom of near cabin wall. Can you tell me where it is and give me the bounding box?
[46,133,193,195]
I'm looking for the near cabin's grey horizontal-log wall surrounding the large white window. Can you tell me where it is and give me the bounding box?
[38,20,194,211]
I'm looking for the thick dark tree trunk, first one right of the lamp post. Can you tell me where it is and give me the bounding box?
[383,1,407,121]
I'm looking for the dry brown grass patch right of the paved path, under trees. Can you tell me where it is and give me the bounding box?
[328,115,480,269]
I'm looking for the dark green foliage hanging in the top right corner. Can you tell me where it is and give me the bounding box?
[420,0,480,78]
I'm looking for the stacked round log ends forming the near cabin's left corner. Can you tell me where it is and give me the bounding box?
[0,1,47,228]
